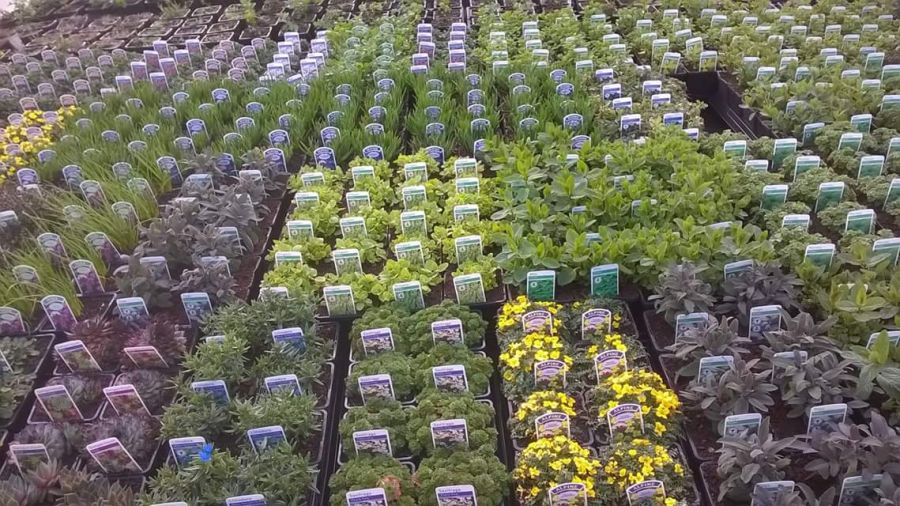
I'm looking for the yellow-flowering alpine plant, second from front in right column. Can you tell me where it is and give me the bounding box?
[585,369,682,442]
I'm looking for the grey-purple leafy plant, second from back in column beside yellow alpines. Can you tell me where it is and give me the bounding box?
[666,316,750,377]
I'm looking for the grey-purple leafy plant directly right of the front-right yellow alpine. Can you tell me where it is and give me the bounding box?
[716,417,797,501]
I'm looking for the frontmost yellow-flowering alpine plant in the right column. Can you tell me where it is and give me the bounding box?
[598,438,695,506]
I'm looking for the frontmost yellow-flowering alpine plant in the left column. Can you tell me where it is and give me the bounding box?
[513,436,600,506]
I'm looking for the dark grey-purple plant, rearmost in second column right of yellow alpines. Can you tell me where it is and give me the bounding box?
[716,264,802,325]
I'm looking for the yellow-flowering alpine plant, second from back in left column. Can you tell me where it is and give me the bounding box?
[500,332,574,401]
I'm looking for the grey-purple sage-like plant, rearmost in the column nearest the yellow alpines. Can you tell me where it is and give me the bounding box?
[649,262,716,324]
